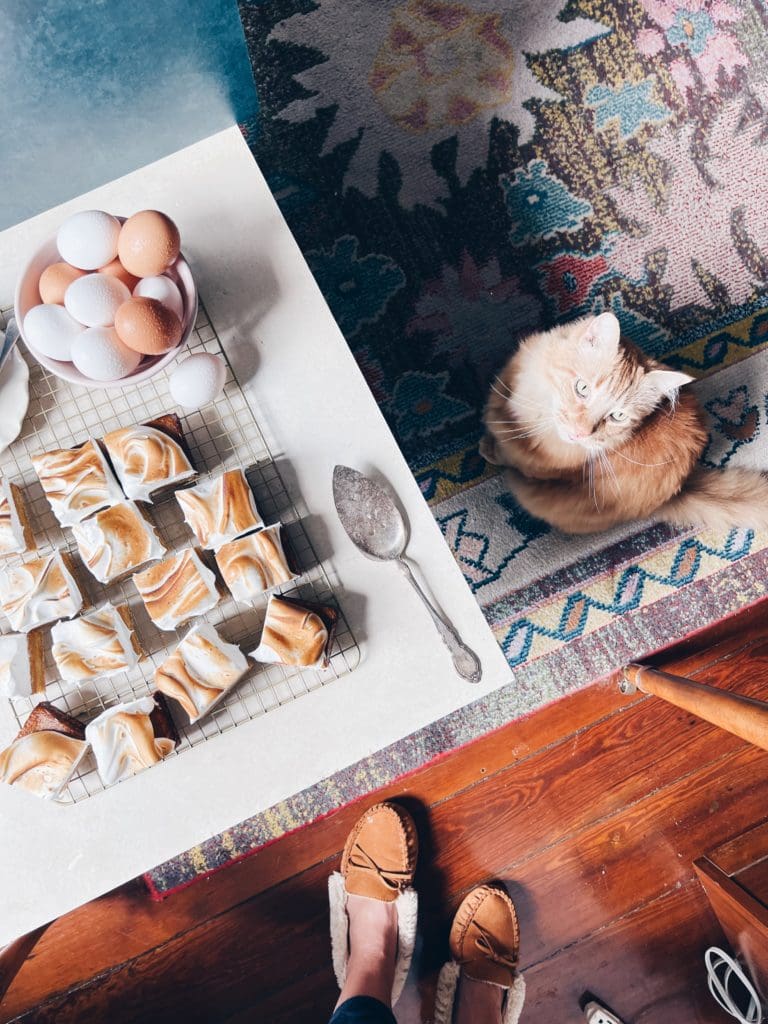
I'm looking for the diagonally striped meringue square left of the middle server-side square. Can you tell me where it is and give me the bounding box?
[133,548,219,630]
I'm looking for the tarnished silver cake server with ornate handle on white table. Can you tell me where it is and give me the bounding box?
[334,466,482,683]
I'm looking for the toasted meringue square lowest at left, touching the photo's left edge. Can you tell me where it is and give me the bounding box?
[0,700,87,800]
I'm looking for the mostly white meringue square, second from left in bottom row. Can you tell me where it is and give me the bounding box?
[85,694,178,785]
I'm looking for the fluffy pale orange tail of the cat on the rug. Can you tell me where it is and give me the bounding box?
[653,469,768,530]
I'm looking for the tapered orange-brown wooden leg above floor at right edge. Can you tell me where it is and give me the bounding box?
[624,665,768,751]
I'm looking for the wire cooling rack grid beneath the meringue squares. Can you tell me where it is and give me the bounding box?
[0,305,359,801]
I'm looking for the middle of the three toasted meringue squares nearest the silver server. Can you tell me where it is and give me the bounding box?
[216,523,297,604]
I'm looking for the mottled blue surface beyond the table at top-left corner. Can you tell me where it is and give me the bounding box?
[0,0,258,228]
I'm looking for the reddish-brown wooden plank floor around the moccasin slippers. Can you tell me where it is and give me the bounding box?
[0,602,768,1024]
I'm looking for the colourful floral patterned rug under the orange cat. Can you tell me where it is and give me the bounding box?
[143,0,768,892]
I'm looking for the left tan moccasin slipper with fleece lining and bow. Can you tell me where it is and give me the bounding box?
[328,803,419,1005]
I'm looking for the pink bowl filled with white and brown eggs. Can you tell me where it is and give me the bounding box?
[14,210,198,388]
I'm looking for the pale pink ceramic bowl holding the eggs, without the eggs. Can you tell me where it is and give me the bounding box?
[13,230,198,388]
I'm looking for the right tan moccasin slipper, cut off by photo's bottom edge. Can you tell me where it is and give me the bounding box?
[435,886,525,1024]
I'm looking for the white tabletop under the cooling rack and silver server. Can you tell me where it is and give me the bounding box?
[0,128,518,946]
